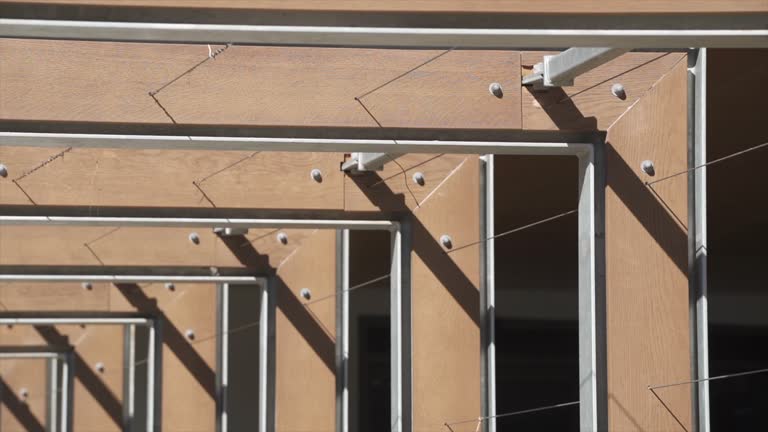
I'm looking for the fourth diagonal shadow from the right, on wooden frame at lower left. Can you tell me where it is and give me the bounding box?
[110,283,216,398]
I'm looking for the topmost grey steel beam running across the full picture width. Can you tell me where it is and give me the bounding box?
[0,18,768,49]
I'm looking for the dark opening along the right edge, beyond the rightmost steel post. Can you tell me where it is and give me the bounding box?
[707,50,768,432]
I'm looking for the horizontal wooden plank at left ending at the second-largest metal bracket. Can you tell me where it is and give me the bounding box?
[0,147,343,209]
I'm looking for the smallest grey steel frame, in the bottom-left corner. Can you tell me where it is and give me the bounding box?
[0,345,75,432]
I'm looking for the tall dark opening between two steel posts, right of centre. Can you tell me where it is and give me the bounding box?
[494,156,579,431]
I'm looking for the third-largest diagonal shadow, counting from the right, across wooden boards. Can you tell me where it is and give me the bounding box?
[221,235,336,373]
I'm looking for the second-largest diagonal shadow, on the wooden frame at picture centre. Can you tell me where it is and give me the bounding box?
[349,173,480,327]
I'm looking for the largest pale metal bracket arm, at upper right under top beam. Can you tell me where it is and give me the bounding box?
[523,47,629,88]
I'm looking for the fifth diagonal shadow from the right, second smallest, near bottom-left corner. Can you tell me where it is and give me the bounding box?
[35,326,123,427]
